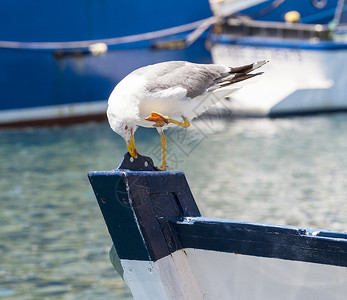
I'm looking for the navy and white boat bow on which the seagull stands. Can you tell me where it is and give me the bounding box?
[88,153,347,300]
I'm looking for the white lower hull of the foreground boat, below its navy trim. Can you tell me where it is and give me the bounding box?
[121,249,347,300]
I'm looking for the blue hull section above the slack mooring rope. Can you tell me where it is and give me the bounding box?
[0,0,211,42]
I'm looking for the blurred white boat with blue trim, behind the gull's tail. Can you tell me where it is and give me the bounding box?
[210,0,347,116]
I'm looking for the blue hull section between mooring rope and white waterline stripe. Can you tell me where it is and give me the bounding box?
[0,39,212,110]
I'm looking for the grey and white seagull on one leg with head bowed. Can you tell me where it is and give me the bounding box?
[107,60,268,170]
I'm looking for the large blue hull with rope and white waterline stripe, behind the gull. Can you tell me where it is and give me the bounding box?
[0,0,211,126]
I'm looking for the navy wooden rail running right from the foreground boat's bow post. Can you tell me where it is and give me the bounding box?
[173,218,347,267]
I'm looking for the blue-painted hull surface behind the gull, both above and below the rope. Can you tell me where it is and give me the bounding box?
[0,0,212,111]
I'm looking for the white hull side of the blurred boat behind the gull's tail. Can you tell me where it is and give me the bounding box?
[212,44,347,116]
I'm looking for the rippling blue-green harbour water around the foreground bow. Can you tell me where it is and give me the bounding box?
[0,114,347,299]
